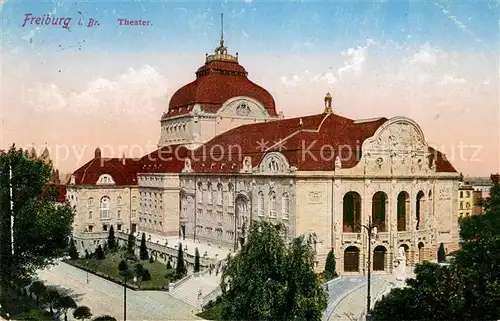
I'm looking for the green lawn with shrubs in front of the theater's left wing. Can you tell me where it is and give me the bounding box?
[69,251,172,289]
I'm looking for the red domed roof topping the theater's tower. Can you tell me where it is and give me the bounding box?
[163,61,277,118]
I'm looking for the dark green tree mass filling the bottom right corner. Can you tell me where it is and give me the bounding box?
[373,182,500,321]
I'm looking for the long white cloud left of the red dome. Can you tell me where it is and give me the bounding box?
[28,65,167,115]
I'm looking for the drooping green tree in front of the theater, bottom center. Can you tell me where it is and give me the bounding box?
[221,222,327,321]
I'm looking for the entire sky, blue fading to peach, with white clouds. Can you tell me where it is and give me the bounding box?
[0,0,500,175]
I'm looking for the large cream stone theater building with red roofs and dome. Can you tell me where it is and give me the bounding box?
[68,40,460,273]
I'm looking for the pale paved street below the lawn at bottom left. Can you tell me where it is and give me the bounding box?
[39,263,201,321]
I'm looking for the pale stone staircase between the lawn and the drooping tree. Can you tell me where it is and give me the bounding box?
[170,272,221,308]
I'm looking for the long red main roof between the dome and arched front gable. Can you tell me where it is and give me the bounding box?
[188,114,455,173]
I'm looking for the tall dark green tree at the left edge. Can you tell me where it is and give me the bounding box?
[0,146,74,286]
